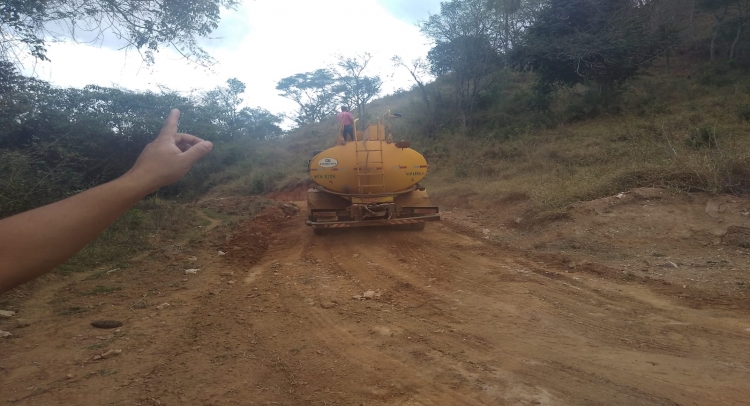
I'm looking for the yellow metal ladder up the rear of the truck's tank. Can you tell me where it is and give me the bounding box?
[354,123,385,194]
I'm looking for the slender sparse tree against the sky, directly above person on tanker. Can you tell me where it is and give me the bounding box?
[337,52,383,124]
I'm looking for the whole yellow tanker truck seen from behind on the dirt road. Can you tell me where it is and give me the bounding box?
[306,112,440,234]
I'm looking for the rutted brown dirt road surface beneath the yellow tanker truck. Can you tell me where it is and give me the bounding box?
[0,197,750,405]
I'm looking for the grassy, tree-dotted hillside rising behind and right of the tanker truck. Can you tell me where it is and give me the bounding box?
[212,61,750,222]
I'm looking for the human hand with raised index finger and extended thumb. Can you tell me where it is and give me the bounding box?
[126,109,213,193]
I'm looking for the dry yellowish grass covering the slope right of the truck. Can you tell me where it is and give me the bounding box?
[415,61,750,219]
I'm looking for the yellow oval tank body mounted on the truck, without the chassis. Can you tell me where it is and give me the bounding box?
[309,140,428,194]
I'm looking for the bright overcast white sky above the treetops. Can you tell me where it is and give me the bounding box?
[20,0,440,124]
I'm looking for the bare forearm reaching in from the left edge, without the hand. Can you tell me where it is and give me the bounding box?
[0,175,151,293]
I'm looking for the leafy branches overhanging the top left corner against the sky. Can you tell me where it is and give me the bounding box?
[0,0,238,64]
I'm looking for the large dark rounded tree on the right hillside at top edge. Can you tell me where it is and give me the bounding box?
[512,0,675,97]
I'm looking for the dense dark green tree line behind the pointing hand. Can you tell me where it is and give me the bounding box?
[0,62,282,217]
